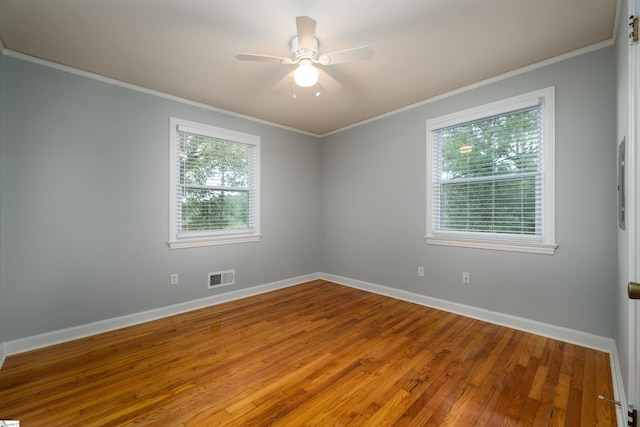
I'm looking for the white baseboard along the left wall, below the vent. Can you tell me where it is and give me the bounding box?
[3,273,320,356]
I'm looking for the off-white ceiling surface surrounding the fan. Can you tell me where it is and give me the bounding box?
[0,0,619,135]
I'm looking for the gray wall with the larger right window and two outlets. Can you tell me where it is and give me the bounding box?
[321,47,616,337]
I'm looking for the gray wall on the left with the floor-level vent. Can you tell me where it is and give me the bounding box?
[0,56,320,342]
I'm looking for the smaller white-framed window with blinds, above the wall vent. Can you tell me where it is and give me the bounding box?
[169,118,260,248]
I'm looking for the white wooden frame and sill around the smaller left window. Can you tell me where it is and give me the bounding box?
[168,117,262,249]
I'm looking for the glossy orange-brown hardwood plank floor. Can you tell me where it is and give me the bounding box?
[0,280,616,427]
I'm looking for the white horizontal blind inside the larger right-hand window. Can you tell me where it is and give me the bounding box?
[432,103,543,241]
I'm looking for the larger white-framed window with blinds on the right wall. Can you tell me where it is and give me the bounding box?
[425,88,557,254]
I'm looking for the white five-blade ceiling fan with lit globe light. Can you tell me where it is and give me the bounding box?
[236,16,373,98]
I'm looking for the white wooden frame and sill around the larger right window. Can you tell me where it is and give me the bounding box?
[425,87,558,255]
